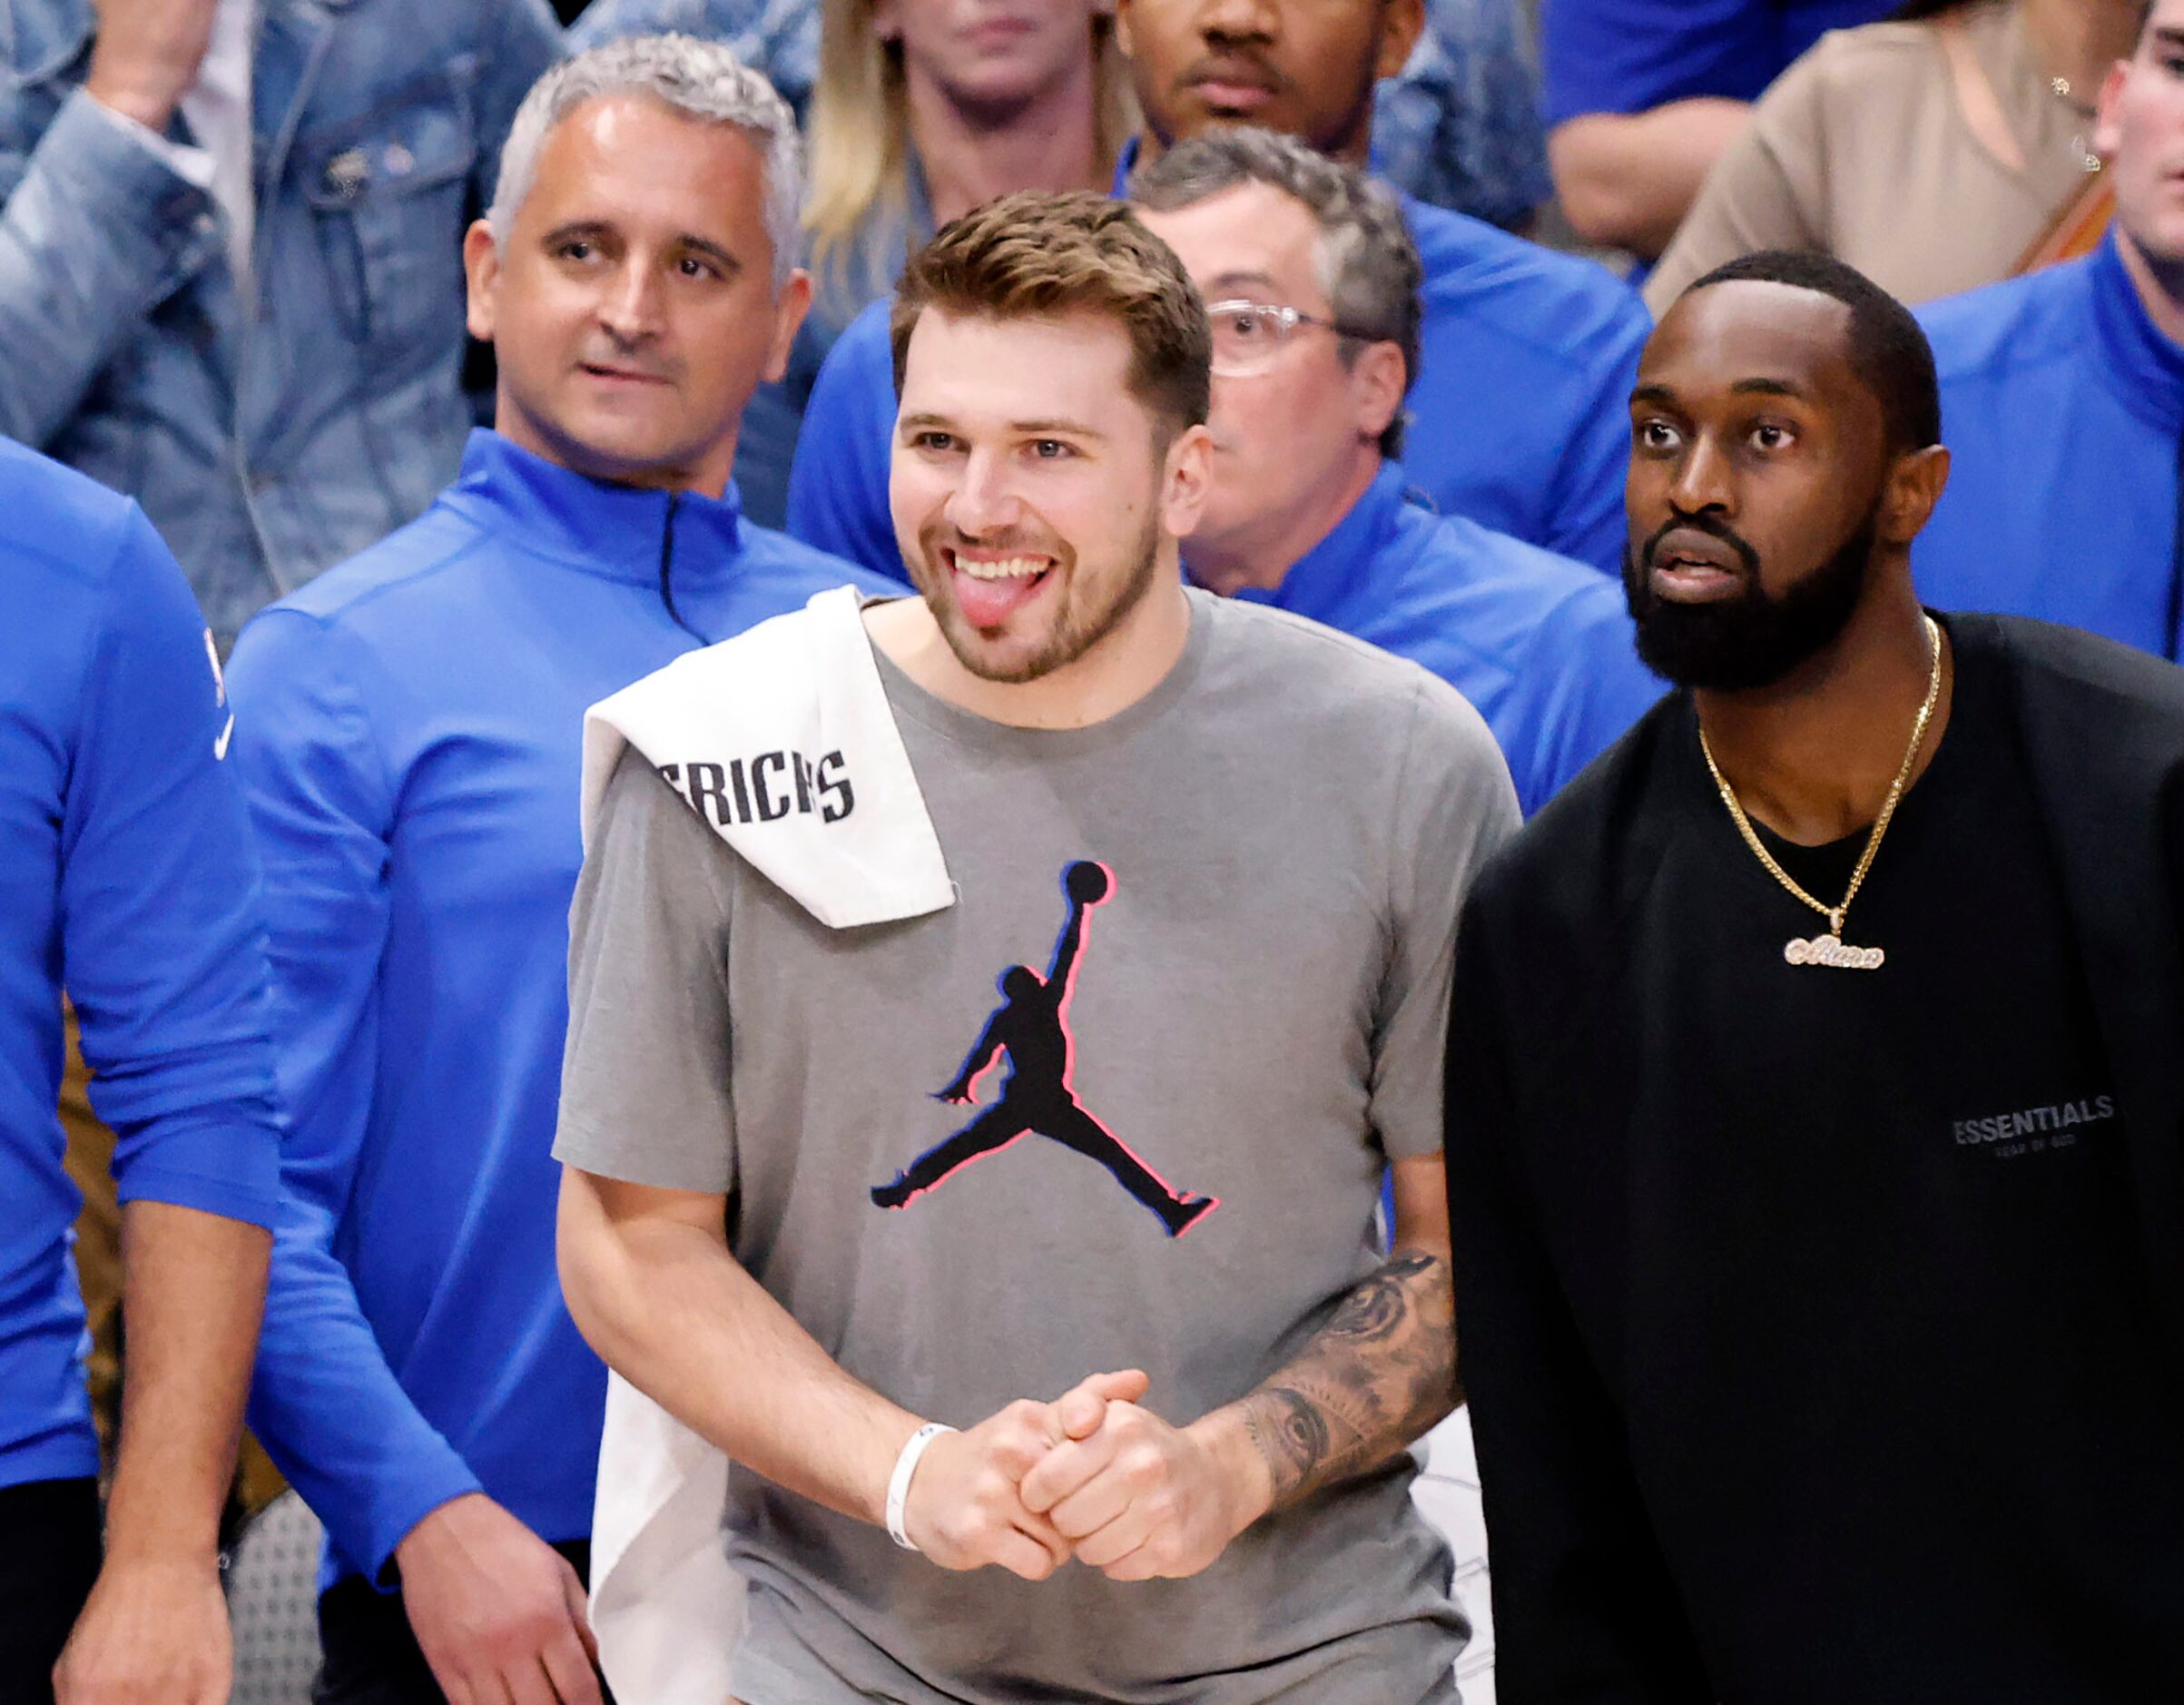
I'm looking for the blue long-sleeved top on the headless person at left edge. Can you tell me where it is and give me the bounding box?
[0,439,280,1493]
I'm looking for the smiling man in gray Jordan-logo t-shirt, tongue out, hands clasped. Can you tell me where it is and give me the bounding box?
[557,196,1516,1705]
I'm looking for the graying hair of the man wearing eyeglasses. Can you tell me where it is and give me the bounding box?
[1129,124,1424,457]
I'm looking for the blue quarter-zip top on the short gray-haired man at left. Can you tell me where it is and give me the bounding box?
[230,432,895,1579]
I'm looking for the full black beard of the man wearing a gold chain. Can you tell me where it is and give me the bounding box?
[1623,504,1881,692]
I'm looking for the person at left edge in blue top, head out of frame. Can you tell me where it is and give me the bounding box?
[0,439,280,1705]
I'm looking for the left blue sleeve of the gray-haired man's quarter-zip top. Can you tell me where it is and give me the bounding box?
[230,609,478,1576]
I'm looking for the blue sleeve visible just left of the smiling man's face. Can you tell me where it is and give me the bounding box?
[789,301,902,581]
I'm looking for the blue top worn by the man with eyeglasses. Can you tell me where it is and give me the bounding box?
[1231,463,1667,816]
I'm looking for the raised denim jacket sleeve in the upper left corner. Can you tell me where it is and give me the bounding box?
[0,85,221,448]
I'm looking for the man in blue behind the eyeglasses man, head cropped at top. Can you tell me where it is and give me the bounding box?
[789,0,1651,577]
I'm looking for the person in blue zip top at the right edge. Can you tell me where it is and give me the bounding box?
[1911,0,2184,659]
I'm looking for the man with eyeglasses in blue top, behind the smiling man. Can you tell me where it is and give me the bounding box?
[1131,129,1662,814]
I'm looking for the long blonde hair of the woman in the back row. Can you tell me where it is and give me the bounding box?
[803,0,1138,288]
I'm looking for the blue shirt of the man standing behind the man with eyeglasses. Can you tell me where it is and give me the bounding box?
[789,142,1653,577]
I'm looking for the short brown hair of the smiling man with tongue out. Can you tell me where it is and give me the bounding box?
[887,190,1212,437]
